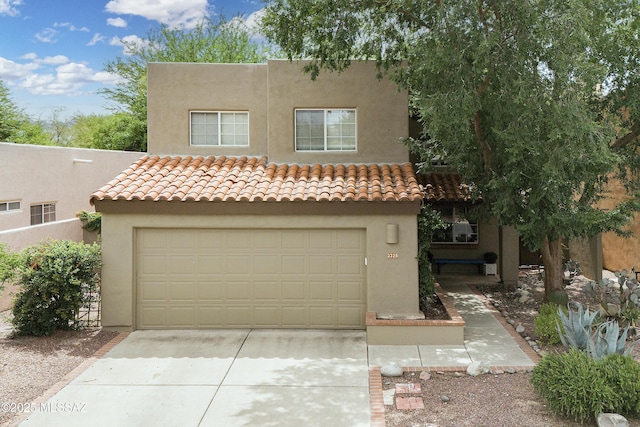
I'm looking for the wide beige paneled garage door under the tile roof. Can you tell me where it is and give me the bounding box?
[136,229,366,329]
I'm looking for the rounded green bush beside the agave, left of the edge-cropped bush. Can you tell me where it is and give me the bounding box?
[531,349,619,423]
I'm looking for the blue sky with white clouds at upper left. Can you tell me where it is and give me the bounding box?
[0,0,264,120]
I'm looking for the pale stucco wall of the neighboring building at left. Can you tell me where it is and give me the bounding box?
[0,143,141,232]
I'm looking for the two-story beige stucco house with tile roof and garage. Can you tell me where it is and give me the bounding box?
[91,61,520,338]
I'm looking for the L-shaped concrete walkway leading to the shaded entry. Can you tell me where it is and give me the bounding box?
[369,276,537,370]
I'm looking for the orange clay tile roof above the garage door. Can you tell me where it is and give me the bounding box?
[91,155,423,203]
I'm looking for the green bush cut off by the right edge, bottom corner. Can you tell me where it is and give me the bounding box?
[599,354,640,417]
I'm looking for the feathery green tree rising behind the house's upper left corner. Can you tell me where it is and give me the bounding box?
[100,16,267,151]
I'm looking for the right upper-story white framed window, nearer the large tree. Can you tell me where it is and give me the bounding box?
[295,109,357,151]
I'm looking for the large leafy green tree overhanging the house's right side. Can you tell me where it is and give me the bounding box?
[263,0,640,295]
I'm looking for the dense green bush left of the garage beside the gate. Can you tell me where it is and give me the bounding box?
[12,240,100,336]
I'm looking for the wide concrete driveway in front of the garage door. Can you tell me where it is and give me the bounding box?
[20,330,371,427]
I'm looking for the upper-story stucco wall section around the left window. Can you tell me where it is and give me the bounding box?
[147,63,268,156]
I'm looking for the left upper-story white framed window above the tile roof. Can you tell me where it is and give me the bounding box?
[190,111,249,146]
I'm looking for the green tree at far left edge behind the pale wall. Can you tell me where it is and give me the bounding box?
[0,80,51,145]
